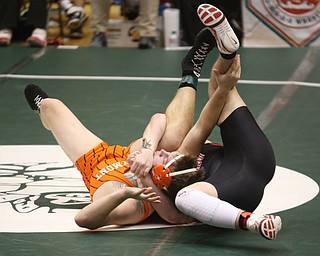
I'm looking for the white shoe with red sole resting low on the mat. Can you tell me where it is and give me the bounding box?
[246,213,282,240]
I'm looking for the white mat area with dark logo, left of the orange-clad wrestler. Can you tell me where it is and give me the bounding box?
[0,145,94,232]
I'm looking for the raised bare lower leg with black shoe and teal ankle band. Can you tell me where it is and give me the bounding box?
[158,28,216,151]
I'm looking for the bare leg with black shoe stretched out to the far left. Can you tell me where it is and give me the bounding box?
[25,85,102,163]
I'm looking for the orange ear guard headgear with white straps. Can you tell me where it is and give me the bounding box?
[152,155,197,190]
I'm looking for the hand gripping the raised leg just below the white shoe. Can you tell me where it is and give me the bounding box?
[213,54,241,91]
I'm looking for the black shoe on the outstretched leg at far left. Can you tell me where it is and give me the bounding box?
[24,84,49,113]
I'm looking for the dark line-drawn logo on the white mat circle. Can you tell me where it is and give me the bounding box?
[0,162,90,213]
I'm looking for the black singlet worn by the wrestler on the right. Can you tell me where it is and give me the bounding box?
[201,106,276,212]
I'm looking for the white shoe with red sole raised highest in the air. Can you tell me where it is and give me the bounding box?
[197,4,240,54]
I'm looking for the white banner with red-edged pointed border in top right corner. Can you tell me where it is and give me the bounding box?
[247,0,320,47]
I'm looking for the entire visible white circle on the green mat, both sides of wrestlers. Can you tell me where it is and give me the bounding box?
[0,145,319,233]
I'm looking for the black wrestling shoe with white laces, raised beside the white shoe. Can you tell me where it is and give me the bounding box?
[181,28,217,78]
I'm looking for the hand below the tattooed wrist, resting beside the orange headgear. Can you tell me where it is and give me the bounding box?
[127,149,153,177]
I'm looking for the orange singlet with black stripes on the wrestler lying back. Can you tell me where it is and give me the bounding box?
[75,142,150,221]
